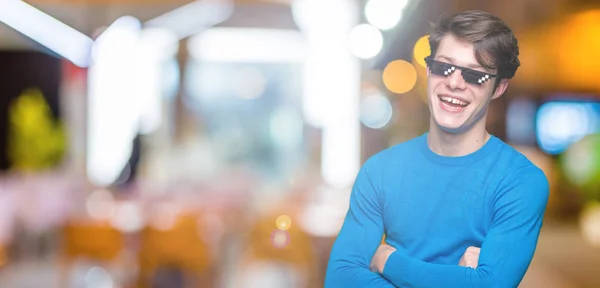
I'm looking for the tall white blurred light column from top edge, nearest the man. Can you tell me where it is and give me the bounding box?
[292,0,358,187]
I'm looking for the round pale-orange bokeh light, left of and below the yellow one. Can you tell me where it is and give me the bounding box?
[383,60,417,94]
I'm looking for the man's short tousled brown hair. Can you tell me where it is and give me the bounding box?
[429,10,520,82]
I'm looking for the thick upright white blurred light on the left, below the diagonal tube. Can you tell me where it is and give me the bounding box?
[87,16,142,186]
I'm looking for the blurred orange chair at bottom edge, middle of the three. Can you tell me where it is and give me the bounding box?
[138,213,215,288]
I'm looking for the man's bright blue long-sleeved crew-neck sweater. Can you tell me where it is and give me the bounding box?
[325,134,549,288]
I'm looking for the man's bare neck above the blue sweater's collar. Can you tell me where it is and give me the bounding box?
[427,120,490,157]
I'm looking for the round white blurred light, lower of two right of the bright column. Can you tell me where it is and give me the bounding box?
[348,24,383,59]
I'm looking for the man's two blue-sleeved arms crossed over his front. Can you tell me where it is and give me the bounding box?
[325,166,548,288]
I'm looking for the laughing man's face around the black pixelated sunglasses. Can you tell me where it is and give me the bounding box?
[427,34,508,134]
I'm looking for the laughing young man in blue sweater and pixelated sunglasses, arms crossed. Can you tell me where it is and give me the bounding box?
[325,11,549,288]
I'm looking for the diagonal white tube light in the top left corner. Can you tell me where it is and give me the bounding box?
[0,0,93,67]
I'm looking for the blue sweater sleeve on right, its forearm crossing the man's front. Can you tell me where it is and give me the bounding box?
[383,165,549,287]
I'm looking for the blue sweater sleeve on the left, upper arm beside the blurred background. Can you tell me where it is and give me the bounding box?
[325,161,394,288]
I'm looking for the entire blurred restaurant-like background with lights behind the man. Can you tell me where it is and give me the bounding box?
[0,0,600,288]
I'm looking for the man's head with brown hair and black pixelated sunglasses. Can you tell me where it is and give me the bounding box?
[427,11,520,133]
